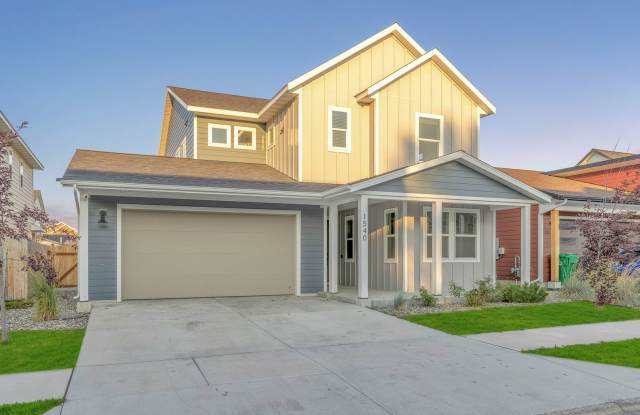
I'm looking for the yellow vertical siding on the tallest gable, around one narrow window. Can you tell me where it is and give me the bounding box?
[301,36,416,183]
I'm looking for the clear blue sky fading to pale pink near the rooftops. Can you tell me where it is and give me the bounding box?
[0,0,640,225]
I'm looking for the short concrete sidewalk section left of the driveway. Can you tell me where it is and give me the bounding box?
[0,369,72,405]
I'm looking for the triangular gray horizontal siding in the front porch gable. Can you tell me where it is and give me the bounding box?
[369,161,527,200]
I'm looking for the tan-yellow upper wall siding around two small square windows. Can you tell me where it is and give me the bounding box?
[196,114,266,164]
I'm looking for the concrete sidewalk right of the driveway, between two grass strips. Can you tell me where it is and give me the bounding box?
[466,320,640,351]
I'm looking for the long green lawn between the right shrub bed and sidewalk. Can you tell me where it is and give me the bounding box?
[404,301,640,335]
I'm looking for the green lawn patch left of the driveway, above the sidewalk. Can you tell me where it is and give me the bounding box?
[0,330,84,374]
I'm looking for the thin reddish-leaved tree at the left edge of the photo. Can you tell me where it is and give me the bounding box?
[0,122,51,343]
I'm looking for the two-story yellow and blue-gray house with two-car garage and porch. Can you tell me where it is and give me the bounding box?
[61,24,551,303]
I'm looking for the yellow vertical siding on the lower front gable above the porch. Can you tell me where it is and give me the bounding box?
[378,61,478,173]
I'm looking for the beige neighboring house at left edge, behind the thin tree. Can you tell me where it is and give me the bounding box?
[0,111,44,223]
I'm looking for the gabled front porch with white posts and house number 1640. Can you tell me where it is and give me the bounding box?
[326,151,547,305]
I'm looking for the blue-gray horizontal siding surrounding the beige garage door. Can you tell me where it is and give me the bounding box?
[88,196,324,300]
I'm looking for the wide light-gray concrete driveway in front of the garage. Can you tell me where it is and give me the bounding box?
[62,297,640,415]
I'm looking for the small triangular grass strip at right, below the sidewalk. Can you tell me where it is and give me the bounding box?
[527,339,640,369]
